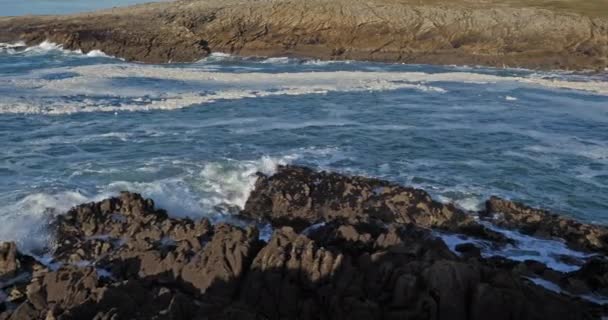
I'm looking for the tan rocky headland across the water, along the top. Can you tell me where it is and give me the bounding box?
[0,0,608,69]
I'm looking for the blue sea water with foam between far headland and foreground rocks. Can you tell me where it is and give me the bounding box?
[0,38,608,270]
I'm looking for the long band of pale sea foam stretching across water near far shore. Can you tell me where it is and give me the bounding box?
[0,63,608,114]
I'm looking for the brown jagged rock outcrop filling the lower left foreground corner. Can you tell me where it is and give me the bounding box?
[0,193,262,319]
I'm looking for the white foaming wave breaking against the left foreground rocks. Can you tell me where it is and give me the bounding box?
[0,154,298,252]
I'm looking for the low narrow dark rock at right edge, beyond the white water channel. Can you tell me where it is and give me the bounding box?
[484,197,608,254]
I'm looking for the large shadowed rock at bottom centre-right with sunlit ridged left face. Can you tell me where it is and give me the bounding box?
[235,223,597,319]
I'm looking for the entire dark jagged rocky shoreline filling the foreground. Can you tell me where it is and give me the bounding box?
[0,166,608,320]
